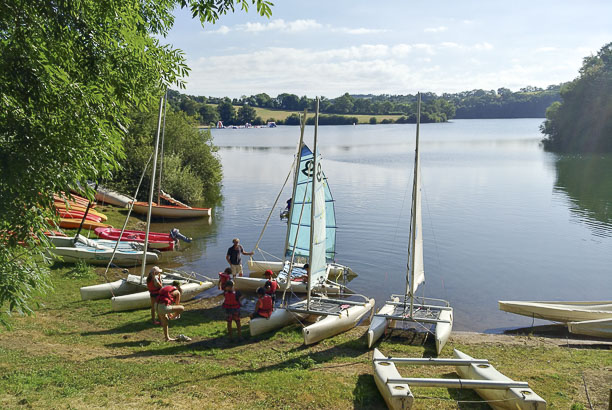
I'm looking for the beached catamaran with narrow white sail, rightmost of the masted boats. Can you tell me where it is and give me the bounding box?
[368,93,453,354]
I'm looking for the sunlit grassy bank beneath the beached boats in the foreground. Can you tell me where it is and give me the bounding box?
[0,255,612,409]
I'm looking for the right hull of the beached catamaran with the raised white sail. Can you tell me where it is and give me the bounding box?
[302,299,375,345]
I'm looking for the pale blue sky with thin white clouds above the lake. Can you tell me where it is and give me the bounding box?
[162,0,612,98]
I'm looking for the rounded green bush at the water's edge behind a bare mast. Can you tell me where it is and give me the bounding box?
[113,107,223,203]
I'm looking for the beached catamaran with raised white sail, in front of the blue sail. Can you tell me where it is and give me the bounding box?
[251,99,375,345]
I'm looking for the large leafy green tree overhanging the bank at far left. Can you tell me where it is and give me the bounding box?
[0,0,272,320]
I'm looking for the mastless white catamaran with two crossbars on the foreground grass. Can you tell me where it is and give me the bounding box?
[372,349,546,410]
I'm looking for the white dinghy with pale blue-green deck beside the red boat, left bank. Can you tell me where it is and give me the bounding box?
[48,235,159,266]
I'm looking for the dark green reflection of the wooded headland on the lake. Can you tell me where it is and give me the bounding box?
[554,155,612,237]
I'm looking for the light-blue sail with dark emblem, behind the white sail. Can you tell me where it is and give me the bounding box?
[285,145,336,263]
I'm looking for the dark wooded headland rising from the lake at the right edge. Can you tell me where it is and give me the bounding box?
[541,43,612,152]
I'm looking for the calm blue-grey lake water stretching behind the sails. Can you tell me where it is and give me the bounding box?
[149,119,612,331]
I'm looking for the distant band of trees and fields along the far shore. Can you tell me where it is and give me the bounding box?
[169,85,561,125]
